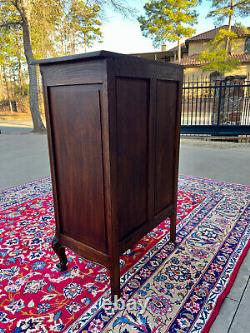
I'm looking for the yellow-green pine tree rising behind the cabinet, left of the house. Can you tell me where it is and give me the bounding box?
[138,0,198,62]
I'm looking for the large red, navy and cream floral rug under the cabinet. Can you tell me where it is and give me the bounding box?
[0,177,250,333]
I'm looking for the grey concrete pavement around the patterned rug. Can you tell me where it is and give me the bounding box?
[0,131,250,333]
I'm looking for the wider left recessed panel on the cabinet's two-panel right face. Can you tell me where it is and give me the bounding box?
[116,78,149,240]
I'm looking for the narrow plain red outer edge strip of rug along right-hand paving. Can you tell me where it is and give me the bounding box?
[202,240,250,333]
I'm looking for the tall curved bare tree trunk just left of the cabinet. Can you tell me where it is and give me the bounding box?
[18,1,45,132]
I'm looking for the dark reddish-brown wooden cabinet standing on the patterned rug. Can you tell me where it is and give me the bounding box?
[36,51,183,296]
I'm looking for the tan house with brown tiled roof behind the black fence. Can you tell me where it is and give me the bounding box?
[134,25,250,79]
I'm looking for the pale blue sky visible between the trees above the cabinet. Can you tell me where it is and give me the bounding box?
[88,0,250,53]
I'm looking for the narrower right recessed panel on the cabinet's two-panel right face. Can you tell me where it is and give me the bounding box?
[155,80,178,215]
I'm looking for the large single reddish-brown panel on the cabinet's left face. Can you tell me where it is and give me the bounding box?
[49,85,106,251]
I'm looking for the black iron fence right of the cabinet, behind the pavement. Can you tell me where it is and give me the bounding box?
[181,76,250,135]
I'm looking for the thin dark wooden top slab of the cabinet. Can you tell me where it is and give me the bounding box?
[31,50,181,68]
